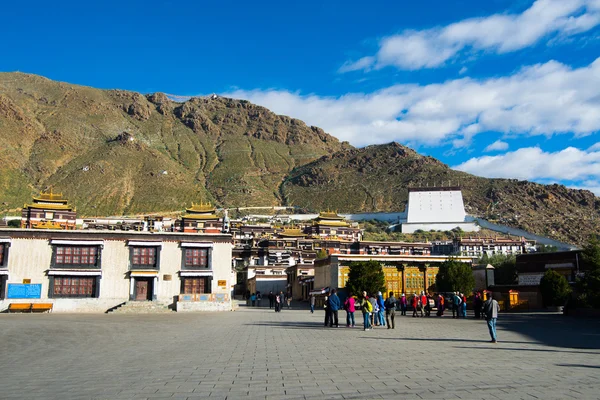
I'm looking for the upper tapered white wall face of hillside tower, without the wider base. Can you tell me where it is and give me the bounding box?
[407,190,466,223]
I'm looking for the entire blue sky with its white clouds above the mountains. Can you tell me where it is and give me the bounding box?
[0,0,600,194]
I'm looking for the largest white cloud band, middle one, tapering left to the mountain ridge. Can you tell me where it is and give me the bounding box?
[225,58,600,146]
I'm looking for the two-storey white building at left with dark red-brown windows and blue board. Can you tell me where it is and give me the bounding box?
[0,228,236,312]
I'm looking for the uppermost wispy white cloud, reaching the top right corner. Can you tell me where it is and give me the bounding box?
[340,0,600,72]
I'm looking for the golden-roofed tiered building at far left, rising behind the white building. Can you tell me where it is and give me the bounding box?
[21,191,77,229]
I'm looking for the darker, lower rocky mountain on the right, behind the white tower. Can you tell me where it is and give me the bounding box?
[282,143,600,245]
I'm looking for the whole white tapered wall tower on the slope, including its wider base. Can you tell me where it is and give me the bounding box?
[402,186,479,233]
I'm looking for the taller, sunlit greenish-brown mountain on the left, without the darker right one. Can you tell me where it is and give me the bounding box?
[0,73,349,216]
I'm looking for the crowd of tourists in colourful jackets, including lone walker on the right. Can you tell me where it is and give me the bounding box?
[318,289,500,343]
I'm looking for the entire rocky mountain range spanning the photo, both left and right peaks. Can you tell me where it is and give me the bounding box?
[0,73,600,244]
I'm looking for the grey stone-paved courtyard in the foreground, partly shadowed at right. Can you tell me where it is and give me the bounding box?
[0,308,600,399]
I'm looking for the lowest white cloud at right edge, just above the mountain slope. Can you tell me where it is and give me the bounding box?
[453,147,600,182]
